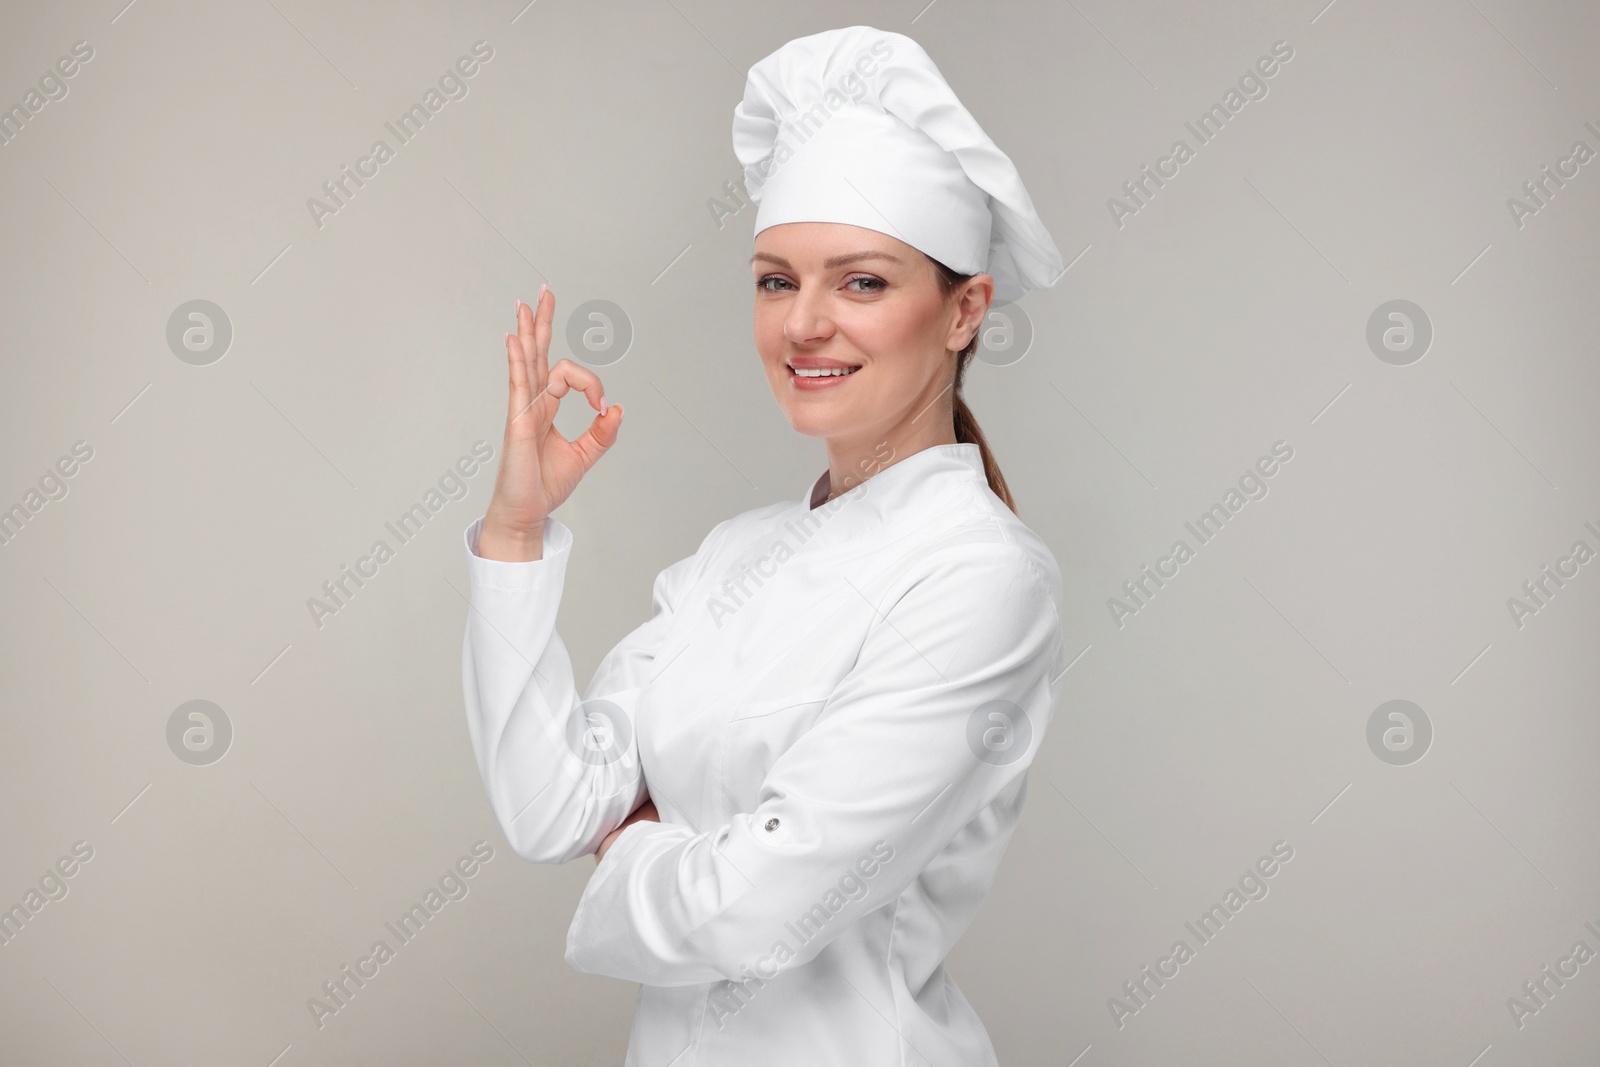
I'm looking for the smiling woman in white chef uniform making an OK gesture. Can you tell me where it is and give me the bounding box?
[462,26,1064,1067]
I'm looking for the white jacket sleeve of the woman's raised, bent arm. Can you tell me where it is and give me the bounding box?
[461,518,694,864]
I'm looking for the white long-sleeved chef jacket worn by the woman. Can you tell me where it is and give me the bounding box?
[462,443,1064,1067]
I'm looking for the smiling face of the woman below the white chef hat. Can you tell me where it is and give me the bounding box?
[750,222,994,448]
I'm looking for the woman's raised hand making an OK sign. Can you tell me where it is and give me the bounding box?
[478,285,622,561]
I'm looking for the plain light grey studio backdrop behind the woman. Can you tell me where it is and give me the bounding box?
[0,0,1600,1067]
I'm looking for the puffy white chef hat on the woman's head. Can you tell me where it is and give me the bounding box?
[733,26,1062,304]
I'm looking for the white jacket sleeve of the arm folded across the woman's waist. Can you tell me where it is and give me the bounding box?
[566,542,1062,985]
